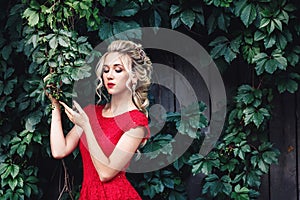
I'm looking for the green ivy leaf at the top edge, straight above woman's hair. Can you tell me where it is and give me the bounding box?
[112,1,140,17]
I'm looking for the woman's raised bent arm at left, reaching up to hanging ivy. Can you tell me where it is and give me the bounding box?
[50,102,82,159]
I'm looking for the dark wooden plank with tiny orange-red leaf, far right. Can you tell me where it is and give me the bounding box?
[270,94,297,200]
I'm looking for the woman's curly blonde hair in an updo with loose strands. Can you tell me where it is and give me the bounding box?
[96,40,152,116]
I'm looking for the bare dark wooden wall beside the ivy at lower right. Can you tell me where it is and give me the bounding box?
[260,92,300,200]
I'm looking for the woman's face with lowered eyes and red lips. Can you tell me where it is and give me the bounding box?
[102,52,130,95]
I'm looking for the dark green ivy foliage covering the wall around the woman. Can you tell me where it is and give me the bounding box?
[0,0,300,199]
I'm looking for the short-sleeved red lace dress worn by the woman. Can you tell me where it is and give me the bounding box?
[79,105,149,200]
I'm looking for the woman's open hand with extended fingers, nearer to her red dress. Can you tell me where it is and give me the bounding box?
[59,101,89,129]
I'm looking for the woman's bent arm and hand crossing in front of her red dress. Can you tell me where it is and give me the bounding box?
[61,102,145,182]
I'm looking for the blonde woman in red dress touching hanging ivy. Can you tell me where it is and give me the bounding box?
[49,40,152,200]
